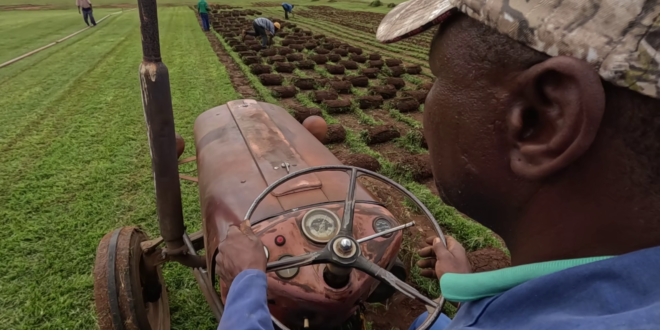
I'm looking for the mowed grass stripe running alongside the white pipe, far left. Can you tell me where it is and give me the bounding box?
[0,14,138,203]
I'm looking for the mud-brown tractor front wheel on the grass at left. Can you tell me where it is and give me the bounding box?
[94,227,170,330]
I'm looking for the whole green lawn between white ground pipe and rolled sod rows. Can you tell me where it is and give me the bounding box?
[0,8,237,329]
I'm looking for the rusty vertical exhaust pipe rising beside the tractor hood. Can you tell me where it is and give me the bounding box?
[138,0,184,251]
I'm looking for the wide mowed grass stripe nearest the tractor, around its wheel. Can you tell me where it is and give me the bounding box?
[0,8,235,329]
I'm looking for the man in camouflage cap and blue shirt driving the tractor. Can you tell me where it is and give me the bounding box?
[216,0,660,330]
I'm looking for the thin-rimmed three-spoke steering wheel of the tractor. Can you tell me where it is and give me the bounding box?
[245,165,447,330]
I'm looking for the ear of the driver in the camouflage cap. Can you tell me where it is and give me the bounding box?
[507,56,605,180]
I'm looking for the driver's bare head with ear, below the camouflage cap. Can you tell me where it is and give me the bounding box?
[424,15,660,231]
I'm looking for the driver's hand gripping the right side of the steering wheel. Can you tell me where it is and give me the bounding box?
[417,236,472,279]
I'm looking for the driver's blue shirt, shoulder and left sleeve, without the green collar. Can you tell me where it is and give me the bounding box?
[218,247,660,330]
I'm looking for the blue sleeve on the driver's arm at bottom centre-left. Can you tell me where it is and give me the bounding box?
[218,269,274,330]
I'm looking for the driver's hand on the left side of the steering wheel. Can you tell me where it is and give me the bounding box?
[215,220,266,286]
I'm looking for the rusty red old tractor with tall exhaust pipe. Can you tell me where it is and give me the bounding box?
[94,0,444,330]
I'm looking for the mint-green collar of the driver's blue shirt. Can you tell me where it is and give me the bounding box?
[440,256,612,302]
